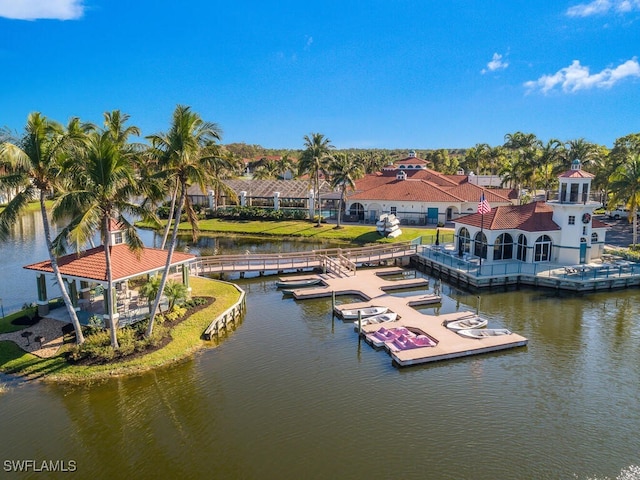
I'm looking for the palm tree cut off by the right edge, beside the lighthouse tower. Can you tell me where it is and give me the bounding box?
[609,152,640,245]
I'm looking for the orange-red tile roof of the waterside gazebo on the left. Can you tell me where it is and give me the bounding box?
[24,244,196,282]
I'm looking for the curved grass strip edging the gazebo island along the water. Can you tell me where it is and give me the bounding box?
[0,278,239,383]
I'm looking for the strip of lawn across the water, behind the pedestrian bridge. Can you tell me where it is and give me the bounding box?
[140,218,436,245]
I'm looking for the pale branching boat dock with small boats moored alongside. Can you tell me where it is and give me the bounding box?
[287,267,528,366]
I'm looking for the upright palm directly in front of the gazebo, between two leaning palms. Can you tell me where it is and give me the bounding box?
[53,130,148,349]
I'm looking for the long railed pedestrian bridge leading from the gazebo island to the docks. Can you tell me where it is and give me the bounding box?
[192,242,417,277]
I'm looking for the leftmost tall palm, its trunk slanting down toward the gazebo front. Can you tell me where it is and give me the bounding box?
[0,112,84,345]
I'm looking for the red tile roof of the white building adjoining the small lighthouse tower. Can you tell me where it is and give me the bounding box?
[456,202,560,232]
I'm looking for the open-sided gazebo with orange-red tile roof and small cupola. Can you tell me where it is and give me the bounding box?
[23,236,196,324]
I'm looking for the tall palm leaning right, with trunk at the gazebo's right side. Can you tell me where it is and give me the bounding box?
[146,105,226,336]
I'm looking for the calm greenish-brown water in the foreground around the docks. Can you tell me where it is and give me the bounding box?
[0,216,640,479]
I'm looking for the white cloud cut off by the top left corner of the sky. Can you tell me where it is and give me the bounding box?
[0,0,84,20]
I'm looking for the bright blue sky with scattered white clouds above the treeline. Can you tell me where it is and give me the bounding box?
[0,0,640,149]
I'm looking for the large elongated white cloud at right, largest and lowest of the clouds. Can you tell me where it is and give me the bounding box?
[524,57,640,93]
